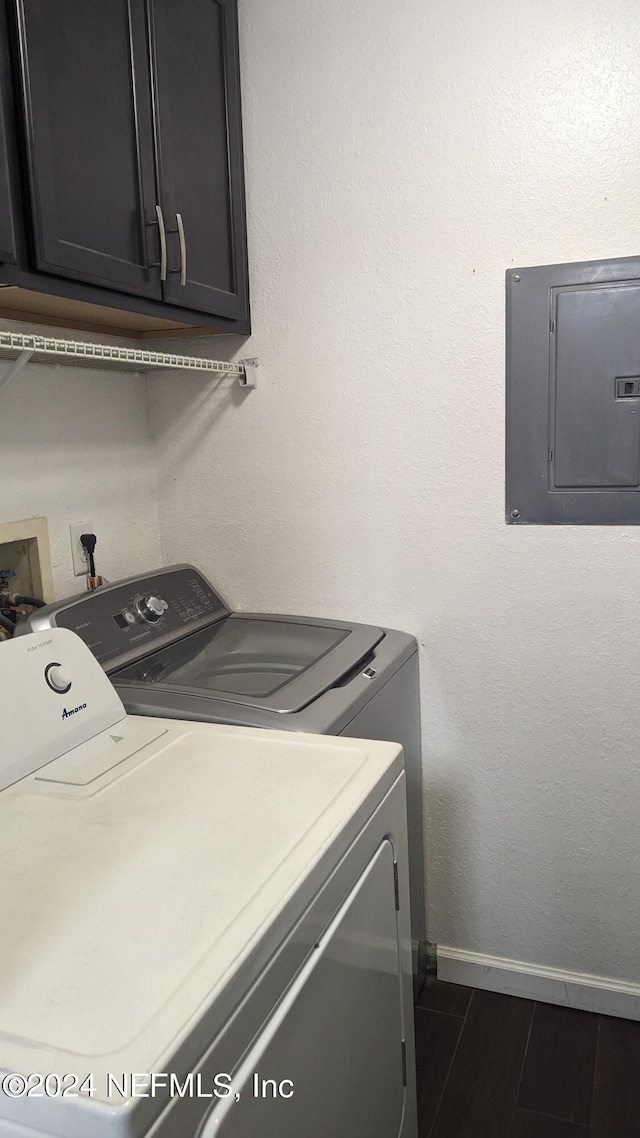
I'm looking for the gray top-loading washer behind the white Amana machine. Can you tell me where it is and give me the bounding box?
[18,564,426,995]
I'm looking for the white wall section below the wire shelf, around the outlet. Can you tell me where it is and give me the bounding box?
[0,321,161,597]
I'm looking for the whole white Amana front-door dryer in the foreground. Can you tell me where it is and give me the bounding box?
[0,629,417,1138]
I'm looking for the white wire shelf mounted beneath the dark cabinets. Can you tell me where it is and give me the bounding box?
[0,332,257,394]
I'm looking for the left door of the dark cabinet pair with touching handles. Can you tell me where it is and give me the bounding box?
[16,0,162,299]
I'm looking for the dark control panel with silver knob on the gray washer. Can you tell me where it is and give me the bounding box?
[18,566,230,671]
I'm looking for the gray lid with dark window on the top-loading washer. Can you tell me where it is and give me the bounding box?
[112,613,385,714]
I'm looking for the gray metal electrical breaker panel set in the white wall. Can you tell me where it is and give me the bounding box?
[507,257,640,526]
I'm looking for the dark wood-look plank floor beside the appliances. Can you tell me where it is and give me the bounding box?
[416,980,640,1138]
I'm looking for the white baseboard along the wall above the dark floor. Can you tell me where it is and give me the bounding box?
[437,945,640,1020]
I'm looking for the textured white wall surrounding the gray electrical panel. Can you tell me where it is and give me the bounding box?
[153,0,640,981]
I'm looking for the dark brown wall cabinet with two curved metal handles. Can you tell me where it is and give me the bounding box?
[0,0,249,336]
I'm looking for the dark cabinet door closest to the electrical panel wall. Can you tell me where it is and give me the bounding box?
[149,0,248,319]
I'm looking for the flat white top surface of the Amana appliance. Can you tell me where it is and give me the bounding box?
[0,718,402,1138]
